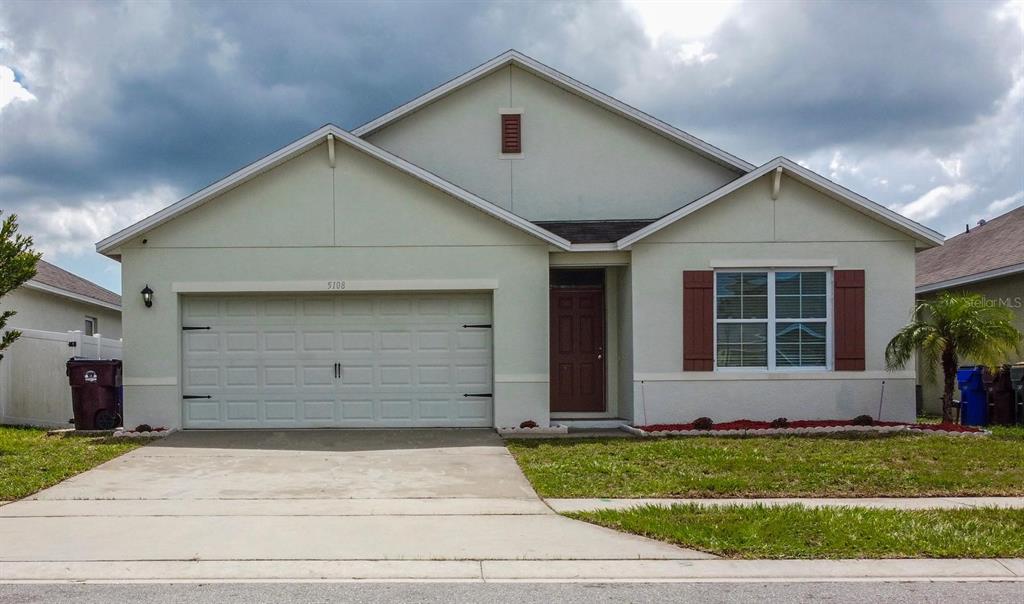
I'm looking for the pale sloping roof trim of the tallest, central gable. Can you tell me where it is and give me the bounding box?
[352,50,754,174]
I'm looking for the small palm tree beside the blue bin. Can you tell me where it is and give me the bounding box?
[886,292,1022,423]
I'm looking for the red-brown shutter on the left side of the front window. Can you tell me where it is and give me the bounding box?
[683,270,715,372]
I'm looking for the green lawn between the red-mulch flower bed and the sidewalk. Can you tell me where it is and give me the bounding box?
[508,428,1024,498]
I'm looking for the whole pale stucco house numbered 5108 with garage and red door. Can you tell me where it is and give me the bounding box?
[97,51,942,429]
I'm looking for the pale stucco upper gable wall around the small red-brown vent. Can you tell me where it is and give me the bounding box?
[368,66,738,220]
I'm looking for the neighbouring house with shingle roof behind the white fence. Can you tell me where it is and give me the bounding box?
[0,260,121,340]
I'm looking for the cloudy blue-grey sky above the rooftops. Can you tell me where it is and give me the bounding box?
[0,0,1024,291]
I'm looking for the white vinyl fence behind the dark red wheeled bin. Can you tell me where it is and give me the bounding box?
[0,330,121,427]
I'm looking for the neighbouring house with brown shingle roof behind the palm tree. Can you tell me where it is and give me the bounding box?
[916,207,1024,414]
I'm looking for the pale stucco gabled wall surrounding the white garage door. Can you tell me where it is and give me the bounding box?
[121,144,549,427]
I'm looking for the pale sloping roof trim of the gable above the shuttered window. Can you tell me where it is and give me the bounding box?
[615,157,942,250]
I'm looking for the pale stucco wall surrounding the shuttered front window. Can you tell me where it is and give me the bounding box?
[632,176,914,423]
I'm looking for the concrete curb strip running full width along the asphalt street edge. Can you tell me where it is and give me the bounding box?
[0,560,1024,583]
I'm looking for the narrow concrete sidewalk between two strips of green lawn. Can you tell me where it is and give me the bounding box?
[545,498,1024,514]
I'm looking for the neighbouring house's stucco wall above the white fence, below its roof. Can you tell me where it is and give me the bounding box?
[0,287,121,340]
